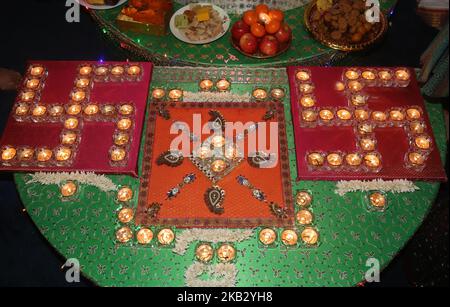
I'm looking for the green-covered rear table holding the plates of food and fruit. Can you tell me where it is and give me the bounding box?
[90,0,396,67]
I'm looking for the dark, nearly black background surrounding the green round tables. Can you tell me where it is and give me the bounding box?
[0,0,449,287]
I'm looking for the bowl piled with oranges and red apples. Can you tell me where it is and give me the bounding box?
[231,4,292,58]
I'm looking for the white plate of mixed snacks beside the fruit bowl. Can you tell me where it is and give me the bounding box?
[169,3,230,44]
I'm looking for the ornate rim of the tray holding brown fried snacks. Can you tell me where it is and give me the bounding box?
[303,1,388,51]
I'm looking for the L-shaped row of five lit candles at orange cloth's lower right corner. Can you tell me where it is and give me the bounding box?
[258,190,319,247]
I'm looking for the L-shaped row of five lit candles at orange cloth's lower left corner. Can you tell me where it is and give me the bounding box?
[115,186,175,246]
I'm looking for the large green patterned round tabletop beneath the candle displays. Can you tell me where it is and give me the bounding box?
[15,67,446,286]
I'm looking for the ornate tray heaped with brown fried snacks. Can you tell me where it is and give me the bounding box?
[304,0,388,51]
